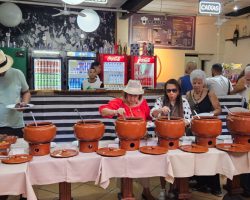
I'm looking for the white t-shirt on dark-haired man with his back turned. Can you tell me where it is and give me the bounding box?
[206,75,233,96]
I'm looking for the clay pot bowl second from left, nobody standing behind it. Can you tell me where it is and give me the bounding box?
[74,120,105,141]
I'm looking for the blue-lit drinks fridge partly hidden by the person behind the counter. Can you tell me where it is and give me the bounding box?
[67,51,96,90]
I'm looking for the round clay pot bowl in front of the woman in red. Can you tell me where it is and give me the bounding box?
[115,117,147,140]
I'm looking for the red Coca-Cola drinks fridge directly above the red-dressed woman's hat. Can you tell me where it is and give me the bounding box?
[130,56,157,88]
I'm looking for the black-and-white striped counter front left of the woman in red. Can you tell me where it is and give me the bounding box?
[24,96,115,141]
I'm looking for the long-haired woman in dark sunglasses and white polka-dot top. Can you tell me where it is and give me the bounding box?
[150,79,191,199]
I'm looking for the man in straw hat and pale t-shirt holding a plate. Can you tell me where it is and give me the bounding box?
[0,50,30,137]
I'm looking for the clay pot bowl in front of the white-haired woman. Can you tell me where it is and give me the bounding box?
[191,116,222,138]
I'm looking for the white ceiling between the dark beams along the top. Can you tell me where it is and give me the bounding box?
[0,0,250,15]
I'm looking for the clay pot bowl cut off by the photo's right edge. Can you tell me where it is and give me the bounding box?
[227,112,250,136]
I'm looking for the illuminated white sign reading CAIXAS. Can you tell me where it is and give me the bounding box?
[199,0,221,15]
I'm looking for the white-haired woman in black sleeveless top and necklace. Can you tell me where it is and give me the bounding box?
[186,69,222,196]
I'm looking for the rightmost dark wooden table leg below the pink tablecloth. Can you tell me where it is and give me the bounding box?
[223,175,243,200]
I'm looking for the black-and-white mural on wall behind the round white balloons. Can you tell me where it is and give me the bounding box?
[0,4,116,51]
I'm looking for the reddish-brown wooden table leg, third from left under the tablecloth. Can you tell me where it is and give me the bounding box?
[175,178,192,200]
